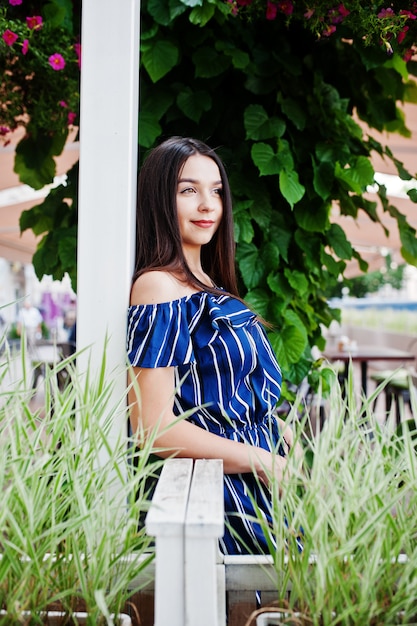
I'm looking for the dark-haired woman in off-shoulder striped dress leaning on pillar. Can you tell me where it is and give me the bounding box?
[127,137,292,554]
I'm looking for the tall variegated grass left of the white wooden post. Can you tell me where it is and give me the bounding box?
[0,338,160,626]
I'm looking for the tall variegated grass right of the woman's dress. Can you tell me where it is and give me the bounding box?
[250,373,417,626]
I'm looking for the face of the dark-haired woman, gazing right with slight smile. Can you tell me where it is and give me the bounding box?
[177,154,223,249]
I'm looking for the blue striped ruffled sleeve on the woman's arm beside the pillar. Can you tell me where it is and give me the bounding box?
[127,299,195,367]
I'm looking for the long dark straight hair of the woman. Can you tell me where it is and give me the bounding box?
[133,137,238,296]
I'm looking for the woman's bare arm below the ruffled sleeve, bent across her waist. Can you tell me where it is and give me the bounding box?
[129,367,286,484]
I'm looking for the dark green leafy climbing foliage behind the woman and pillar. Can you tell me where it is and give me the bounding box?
[0,0,417,383]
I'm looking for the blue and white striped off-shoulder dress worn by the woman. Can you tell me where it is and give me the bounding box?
[127,291,284,554]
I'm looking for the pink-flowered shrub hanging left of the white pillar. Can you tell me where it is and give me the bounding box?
[0,0,81,149]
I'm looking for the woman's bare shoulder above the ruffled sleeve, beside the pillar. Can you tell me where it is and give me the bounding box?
[130,270,187,305]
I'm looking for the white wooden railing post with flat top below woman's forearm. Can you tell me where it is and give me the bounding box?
[141,459,282,626]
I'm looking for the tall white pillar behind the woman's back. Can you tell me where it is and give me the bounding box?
[77,0,140,436]
